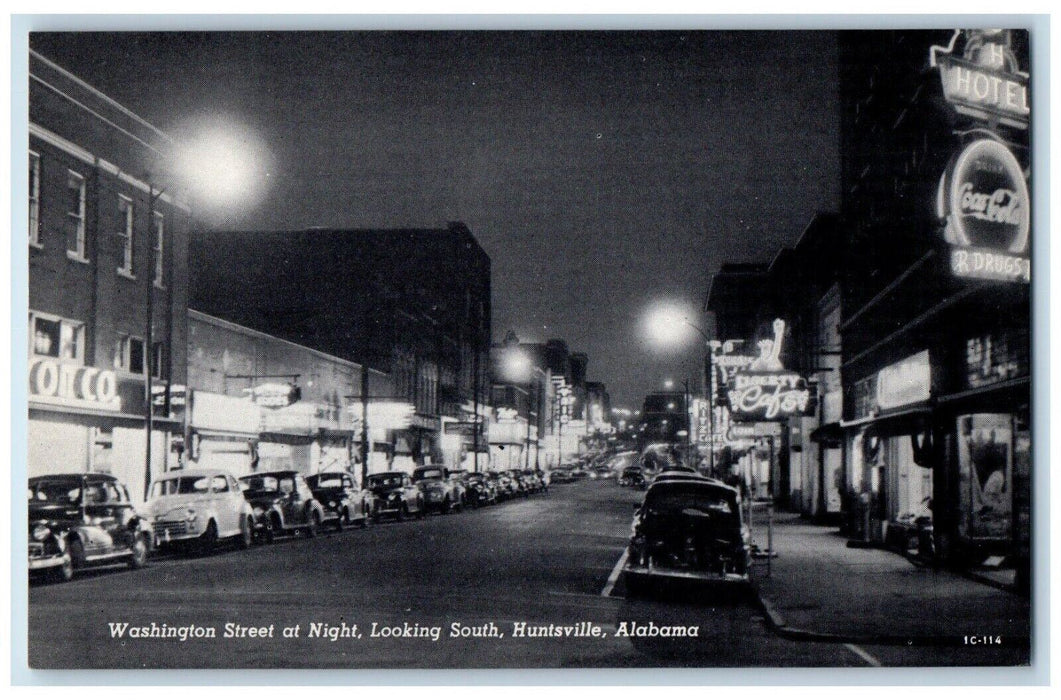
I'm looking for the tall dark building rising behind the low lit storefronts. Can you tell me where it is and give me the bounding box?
[190,223,490,462]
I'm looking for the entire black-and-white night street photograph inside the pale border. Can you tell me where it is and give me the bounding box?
[22,27,1046,682]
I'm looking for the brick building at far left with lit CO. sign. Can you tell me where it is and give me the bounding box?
[27,51,190,501]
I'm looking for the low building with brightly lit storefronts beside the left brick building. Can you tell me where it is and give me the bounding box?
[187,310,394,476]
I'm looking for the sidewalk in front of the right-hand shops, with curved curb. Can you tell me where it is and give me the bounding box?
[752,513,1030,645]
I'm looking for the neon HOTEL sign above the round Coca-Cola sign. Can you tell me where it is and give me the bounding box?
[929,30,1031,128]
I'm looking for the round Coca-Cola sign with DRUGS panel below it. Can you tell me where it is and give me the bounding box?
[937,139,1031,282]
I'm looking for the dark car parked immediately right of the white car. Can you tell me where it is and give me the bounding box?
[240,470,325,542]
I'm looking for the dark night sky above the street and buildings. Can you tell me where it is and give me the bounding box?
[31,32,839,408]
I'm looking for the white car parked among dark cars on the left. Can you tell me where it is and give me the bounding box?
[146,469,255,552]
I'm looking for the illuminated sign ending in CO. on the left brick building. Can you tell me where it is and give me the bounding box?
[30,357,120,410]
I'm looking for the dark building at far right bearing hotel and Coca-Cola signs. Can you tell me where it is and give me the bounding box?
[840,30,1033,571]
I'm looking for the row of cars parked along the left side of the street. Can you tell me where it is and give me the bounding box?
[29,466,547,580]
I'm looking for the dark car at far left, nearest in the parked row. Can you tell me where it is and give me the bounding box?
[29,474,153,581]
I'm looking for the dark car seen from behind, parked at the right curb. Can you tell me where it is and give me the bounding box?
[623,476,751,594]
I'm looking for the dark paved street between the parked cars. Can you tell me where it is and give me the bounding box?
[29,480,1027,668]
